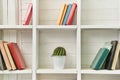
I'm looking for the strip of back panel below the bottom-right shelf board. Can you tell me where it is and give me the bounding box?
[81,74,120,80]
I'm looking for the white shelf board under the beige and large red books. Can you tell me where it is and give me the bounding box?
[0,69,32,74]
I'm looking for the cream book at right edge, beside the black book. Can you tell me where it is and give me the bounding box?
[111,43,120,70]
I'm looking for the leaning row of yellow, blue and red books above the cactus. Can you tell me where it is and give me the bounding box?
[57,3,77,25]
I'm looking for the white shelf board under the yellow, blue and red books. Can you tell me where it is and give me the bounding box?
[37,25,77,30]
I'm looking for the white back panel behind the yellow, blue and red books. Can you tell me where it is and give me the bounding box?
[37,0,77,25]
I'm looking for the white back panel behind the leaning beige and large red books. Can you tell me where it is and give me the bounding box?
[0,28,32,72]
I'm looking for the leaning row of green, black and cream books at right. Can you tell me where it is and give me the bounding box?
[90,40,120,70]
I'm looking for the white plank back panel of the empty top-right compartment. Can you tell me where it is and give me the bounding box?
[81,0,120,25]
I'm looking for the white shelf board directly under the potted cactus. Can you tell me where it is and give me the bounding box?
[37,69,77,74]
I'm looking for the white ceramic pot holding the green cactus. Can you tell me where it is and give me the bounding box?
[53,56,65,69]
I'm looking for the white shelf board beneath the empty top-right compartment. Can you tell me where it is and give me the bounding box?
[81,25,120,29]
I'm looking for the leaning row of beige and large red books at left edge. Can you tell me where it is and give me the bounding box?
[0,40,26,70]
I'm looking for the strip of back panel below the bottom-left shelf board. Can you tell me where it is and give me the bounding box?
[0,74,32,80]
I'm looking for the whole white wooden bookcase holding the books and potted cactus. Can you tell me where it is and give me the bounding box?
[0,0,120,80]
